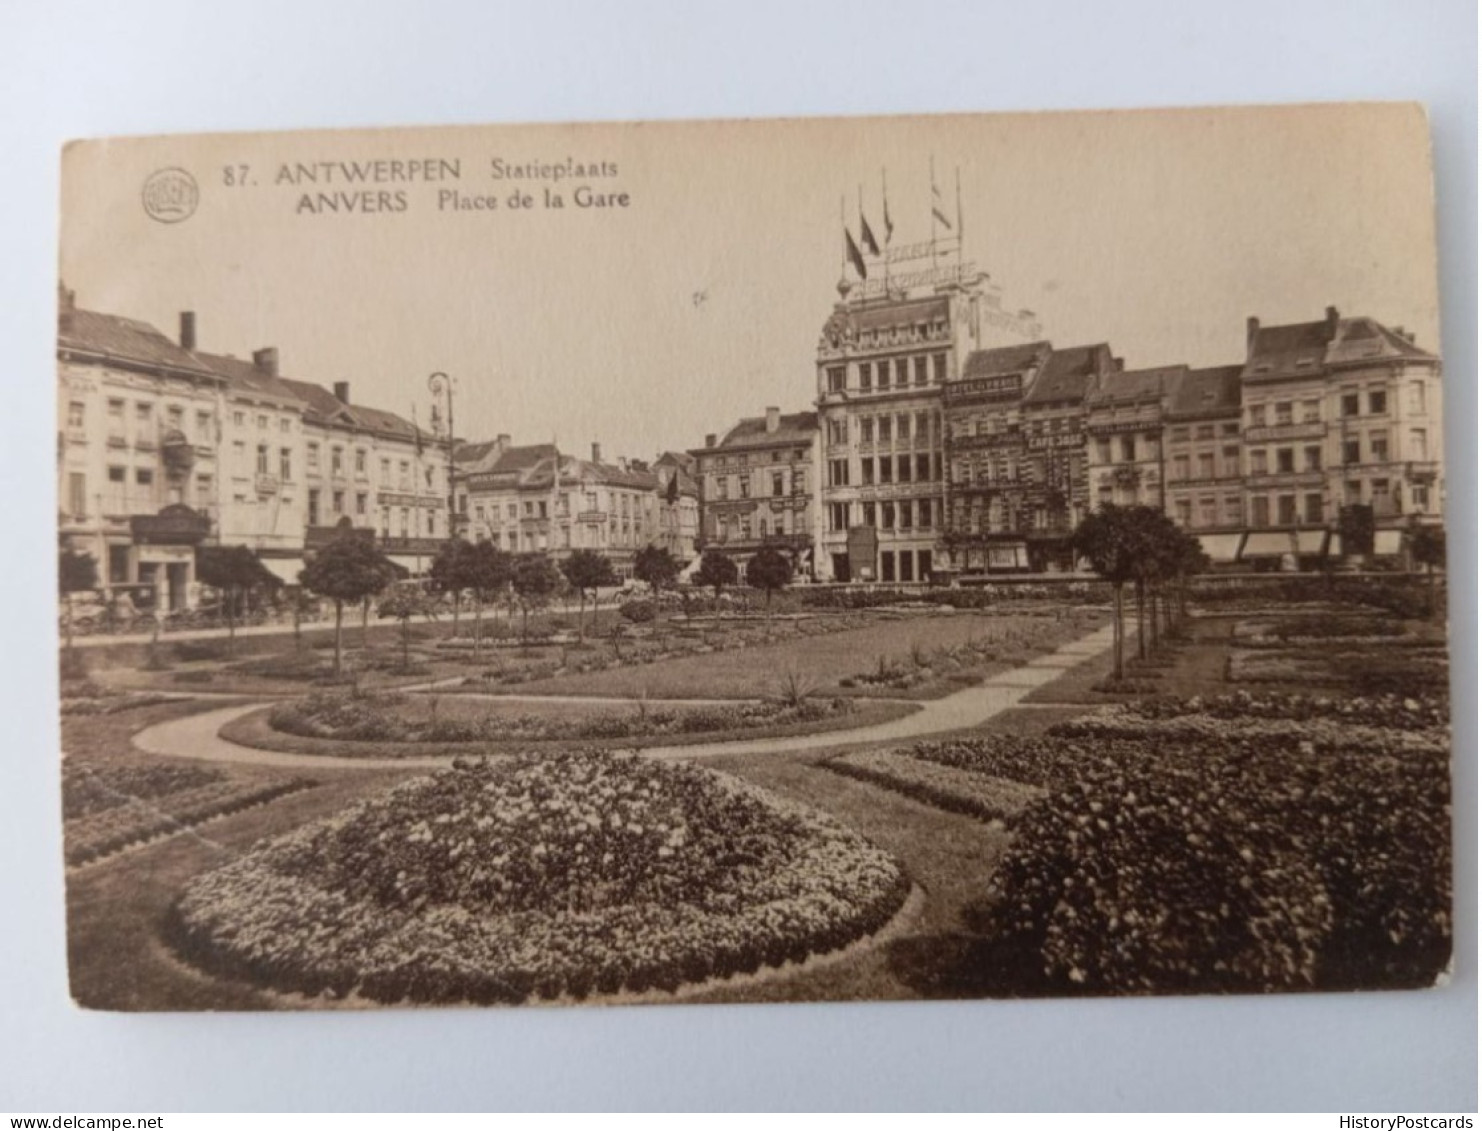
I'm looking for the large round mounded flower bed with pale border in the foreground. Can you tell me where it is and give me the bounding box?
[169,752,908,1004]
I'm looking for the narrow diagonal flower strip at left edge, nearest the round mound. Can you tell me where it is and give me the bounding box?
[65,778,316,866]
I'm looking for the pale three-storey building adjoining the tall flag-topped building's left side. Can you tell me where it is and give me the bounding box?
[691,406,820,575]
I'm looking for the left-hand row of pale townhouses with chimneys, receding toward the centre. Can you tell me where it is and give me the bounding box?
[56,289,700,611]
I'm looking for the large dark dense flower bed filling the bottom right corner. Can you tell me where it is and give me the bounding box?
[907,695,1451,993]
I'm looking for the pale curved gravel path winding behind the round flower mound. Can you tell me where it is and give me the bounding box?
[133,626,1112,769]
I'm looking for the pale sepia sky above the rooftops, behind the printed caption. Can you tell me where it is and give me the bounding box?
[61,104,1439,458]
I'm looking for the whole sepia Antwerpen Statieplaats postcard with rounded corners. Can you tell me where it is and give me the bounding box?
[56,104,1452,1011]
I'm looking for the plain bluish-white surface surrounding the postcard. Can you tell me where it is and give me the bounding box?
[0,0,1478,1113]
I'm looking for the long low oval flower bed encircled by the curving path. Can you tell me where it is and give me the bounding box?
[268,694,855,743]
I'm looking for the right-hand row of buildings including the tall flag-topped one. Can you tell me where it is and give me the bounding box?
[692,262,1443,583]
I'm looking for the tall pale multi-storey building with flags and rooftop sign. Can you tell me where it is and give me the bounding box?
[815,173,1040,581]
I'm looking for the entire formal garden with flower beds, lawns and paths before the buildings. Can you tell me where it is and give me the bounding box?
[54,516,1451,1008]
